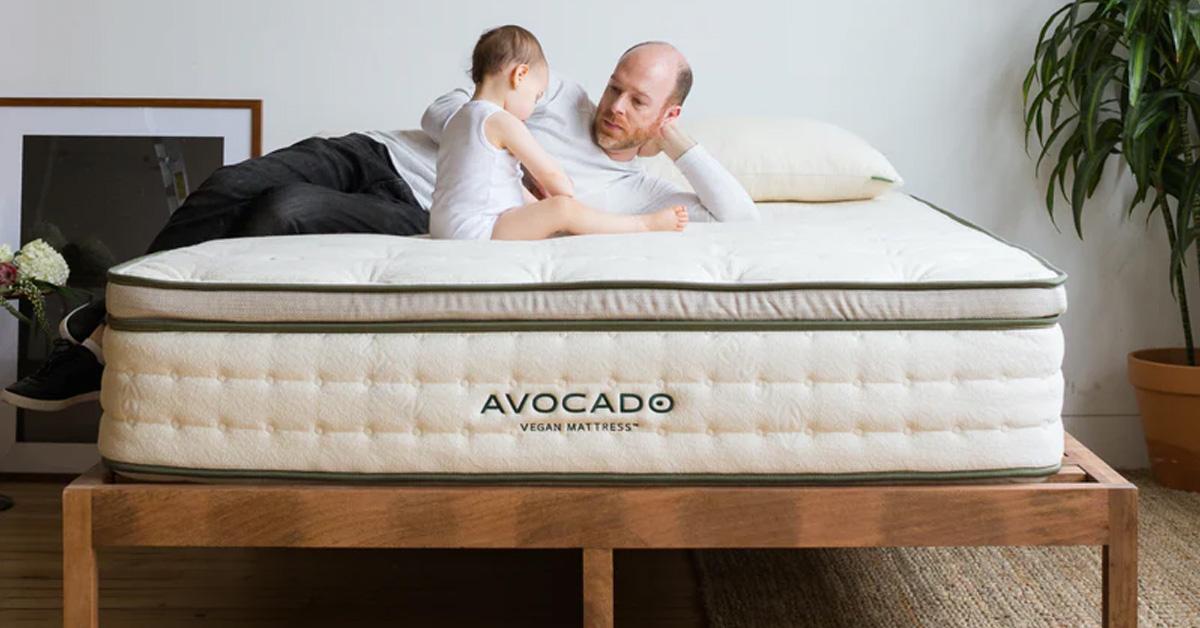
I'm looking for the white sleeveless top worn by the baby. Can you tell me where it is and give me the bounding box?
[430,101,526,240]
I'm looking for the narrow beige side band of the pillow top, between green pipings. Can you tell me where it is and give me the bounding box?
[108,285,1067,323]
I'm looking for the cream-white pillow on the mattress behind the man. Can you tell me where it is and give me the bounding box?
[642,118,904,202]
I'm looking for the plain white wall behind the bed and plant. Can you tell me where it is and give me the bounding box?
[0,0,1185,466]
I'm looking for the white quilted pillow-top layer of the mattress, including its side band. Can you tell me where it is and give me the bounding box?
[108,192,1067,324]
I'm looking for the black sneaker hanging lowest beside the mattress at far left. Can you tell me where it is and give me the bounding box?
[0,339,104,412]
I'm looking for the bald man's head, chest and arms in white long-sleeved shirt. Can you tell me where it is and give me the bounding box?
[421,42,758,222]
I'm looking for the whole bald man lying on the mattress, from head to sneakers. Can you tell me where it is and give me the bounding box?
[0,42,758,411]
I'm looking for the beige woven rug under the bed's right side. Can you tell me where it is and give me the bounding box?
[695,473,1200,628]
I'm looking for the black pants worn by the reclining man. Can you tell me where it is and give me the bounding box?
[89,133,430,326]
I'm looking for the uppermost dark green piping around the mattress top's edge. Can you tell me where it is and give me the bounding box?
[108,196,1067,293]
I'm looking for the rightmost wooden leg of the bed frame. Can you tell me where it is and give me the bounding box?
[1102,488,1138,628]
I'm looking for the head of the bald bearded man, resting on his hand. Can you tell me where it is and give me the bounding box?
[592,46,679,154]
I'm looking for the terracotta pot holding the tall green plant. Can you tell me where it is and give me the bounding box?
[1128,348,1200,492]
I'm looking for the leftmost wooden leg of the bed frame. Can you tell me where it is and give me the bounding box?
[62,475,100,628]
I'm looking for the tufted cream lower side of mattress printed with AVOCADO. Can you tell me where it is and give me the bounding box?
[100,325,1063,474]
